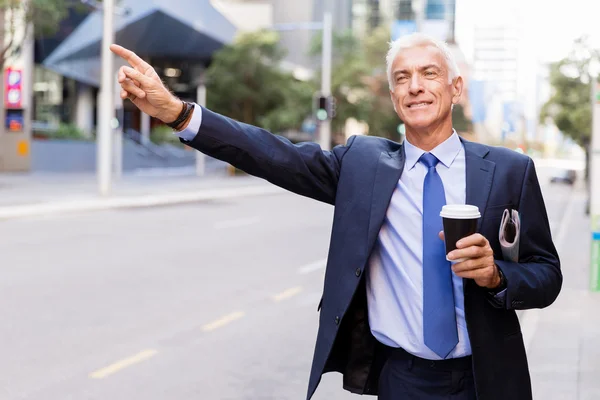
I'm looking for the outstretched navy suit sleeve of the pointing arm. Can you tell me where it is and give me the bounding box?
[180,107,354,204]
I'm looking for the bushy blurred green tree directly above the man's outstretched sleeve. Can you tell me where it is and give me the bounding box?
[206,31,313,132]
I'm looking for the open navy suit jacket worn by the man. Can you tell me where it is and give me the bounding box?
[182,108,562,400]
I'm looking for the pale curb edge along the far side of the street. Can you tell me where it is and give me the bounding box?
[0,185,285,220]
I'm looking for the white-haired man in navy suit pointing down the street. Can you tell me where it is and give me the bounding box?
[111,34,562,400]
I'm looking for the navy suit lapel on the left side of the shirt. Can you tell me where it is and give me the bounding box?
[367,146,405,254]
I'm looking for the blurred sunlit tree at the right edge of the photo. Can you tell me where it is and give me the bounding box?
[540,37,600,149]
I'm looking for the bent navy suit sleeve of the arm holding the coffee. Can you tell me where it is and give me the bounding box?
[496,159,563,310]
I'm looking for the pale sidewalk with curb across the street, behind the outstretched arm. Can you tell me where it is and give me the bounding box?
[0,172,283,219]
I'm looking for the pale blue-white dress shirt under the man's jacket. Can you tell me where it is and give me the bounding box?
[367,132,471,360]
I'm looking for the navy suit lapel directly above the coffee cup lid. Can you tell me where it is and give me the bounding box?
[461,138,496,231]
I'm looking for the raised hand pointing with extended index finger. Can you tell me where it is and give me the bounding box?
[110,44,182,123]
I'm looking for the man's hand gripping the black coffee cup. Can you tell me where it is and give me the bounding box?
[440,232,501,289]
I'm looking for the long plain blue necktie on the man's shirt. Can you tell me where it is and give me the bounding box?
[419,153,458,358]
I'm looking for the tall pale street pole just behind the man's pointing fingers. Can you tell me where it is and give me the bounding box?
[96,0,115,196]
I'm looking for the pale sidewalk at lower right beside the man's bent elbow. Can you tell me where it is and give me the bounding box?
[520,183,600,400]
